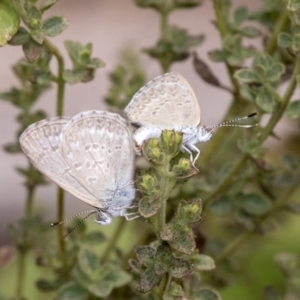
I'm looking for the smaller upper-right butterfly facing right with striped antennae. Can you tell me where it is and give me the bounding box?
[125,72,256,165]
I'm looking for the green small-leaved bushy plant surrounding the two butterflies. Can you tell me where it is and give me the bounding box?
[0,0,300,300]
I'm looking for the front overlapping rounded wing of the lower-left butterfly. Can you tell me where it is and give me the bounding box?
[63,111,134,209]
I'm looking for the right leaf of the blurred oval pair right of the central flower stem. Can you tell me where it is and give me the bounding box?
[236,193,272,216]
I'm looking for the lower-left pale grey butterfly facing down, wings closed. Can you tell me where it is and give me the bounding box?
[20,111,135,224]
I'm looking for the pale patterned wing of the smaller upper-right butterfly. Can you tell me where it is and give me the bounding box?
[125,72,200,129]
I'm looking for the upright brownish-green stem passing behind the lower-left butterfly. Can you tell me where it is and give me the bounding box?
[44,39,68,280]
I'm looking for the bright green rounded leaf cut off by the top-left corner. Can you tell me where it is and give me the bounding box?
[0,0,20,47]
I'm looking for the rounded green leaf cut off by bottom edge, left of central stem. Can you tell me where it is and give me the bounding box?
[57,282,89,300]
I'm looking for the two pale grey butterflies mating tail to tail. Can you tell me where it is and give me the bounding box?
[20,73,252,224]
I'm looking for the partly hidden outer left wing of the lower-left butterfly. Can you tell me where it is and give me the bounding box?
[20,117,94,203]
